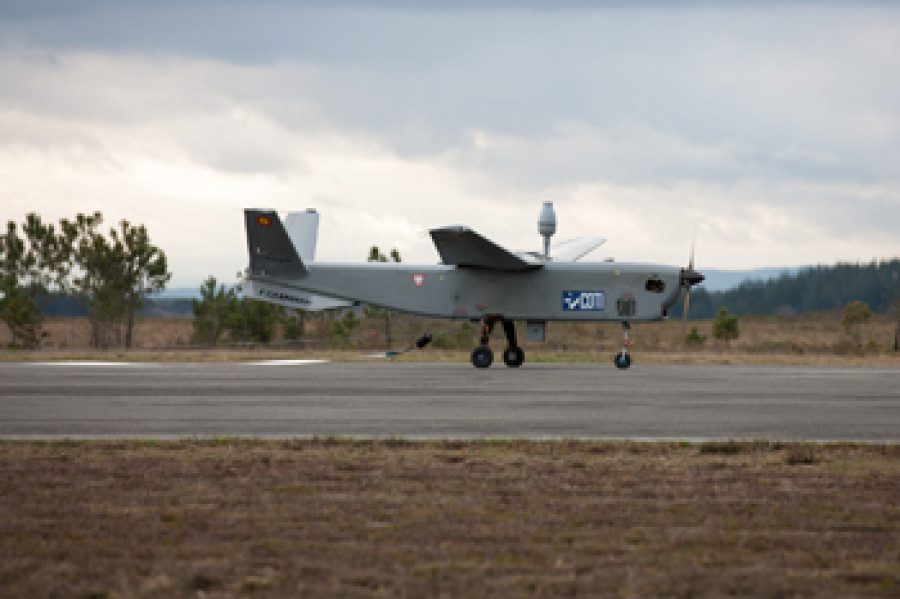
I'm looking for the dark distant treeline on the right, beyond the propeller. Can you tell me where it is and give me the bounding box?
[669,259,900,318]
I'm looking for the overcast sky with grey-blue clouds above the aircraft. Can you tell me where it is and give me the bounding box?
[0,0,900,287]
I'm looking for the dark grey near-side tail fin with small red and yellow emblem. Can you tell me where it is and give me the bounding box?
[244,209,307,277]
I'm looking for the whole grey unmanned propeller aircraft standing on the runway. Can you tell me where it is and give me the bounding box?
[244,202,704,368]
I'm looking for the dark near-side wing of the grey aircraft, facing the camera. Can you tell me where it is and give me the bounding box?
[429,227,543,270]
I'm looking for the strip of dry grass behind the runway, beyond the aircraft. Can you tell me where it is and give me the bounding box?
[7,312,900,366]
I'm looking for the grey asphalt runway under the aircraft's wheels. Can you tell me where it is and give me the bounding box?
[0,362,900,442]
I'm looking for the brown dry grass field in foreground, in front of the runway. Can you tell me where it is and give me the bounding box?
[0,439,900,598]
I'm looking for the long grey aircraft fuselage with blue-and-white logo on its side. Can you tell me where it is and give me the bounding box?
[251,261,682,321]
